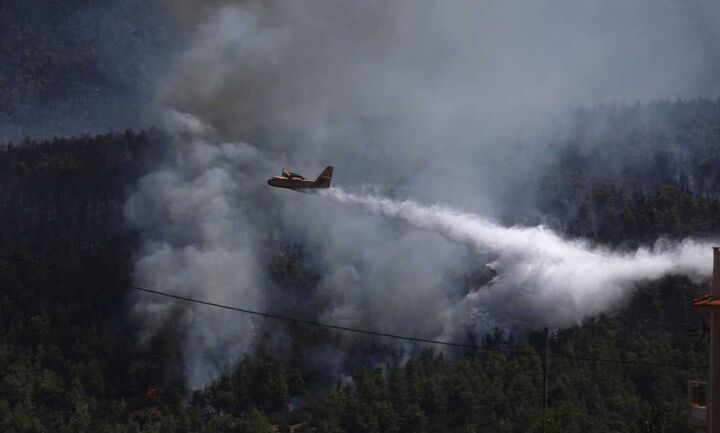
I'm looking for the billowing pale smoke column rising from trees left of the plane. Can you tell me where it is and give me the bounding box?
[125,112,264,388]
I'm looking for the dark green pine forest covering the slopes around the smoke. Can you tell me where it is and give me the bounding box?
[0,100,720,433]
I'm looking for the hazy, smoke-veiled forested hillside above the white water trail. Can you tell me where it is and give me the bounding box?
[537,99,720,224]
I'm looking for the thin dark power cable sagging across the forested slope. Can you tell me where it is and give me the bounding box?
[0,255,708,369]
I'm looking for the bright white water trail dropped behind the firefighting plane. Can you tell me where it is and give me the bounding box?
[321,188,713,335]
